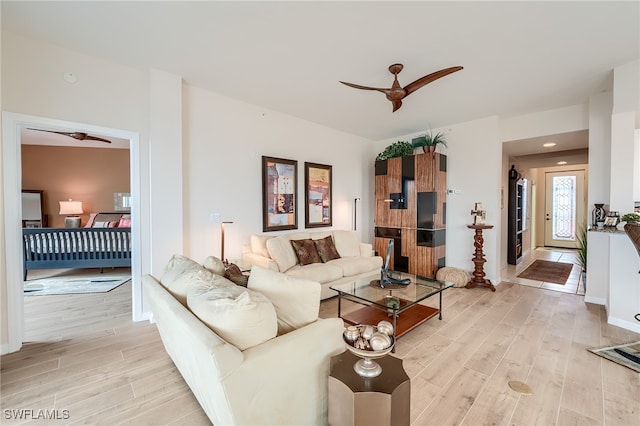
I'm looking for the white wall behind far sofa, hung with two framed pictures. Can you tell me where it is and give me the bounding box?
[184,86,373,266]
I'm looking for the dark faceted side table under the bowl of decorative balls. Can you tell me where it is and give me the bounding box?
[329,351,411,426]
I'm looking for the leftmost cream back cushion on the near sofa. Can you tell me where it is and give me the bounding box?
[160,254,213,306]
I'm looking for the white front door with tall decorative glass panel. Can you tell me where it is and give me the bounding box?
[544,170,586,248]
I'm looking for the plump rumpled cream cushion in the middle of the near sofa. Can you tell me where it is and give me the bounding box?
[185,280,278,351]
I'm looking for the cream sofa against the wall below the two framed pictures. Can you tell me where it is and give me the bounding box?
[242,230,382,300]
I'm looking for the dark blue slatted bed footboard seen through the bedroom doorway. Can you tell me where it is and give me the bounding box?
[22,218,131,280]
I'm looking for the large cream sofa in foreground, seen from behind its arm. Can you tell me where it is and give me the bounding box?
[143,256,344,426]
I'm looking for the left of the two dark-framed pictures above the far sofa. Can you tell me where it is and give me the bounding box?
[262,156,298,232]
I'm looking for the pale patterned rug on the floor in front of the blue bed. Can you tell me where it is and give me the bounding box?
[24,275,131,296]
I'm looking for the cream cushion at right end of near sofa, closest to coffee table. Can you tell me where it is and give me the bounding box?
[248,266,321,335]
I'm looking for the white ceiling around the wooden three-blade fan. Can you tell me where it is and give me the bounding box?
[1,1,640,156]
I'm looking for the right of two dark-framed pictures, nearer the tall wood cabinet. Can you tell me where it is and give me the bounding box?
[304,162,333,228]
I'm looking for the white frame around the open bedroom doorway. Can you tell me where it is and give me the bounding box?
[2,112,147,353]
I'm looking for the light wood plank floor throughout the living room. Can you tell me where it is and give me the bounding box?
[0,254,640,426]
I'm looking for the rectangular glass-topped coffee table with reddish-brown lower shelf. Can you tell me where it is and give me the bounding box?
[330,271,453,349]
